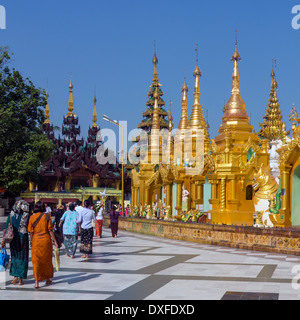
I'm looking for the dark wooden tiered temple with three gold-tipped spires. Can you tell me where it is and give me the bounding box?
[34,82,130,199]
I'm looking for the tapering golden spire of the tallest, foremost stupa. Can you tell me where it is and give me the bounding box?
[223,34,249,124]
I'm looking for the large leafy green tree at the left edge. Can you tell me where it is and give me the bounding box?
[0,47,54,195]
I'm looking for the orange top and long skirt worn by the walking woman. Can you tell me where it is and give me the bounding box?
[28,213,54,281]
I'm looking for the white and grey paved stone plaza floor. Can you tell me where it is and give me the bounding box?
[0,218,300,302]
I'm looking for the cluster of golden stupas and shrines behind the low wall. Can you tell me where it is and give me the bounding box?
[131,42,300,227]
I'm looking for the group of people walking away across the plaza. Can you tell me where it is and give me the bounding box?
[1,200,120,288]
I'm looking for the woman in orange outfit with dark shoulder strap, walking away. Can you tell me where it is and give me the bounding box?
[28,201,58,288]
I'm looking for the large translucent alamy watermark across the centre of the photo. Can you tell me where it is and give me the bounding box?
[96,121,204,175]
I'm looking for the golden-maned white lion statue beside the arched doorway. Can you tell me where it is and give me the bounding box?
[252,166,281,228]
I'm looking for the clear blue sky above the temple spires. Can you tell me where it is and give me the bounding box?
[0,0,300,146]
